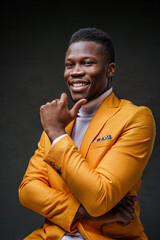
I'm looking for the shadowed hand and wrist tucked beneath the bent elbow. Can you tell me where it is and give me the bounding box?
[75,195,137,225]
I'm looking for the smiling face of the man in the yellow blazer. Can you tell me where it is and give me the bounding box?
[64,41,114,102]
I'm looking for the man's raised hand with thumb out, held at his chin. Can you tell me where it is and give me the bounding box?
[40,93,87,141]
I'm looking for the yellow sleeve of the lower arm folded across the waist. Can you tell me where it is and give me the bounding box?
[19,133,80,232]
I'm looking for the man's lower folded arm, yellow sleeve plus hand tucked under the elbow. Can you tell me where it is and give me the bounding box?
[19,133,135,231]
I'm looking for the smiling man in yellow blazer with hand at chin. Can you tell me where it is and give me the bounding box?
[19,28,155,240]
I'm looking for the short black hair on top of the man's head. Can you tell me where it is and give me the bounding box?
[68,28,115,62]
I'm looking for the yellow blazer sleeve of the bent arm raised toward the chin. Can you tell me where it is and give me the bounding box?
[43,107,155,217]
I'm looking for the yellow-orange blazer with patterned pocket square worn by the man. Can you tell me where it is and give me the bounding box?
[19,93,155,240]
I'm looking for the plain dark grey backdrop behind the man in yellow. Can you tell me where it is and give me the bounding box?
[0,0,160,240]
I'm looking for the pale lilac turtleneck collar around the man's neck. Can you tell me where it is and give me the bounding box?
[78,87,113,117]
